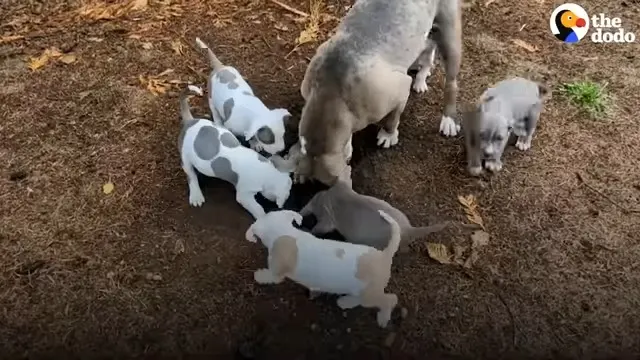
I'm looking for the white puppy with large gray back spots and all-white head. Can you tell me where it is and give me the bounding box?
[178,85,292,219]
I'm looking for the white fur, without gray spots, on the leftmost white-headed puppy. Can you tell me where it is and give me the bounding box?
[180,119,292,218]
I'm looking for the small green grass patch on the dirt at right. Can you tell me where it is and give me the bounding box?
[560,80,610,119]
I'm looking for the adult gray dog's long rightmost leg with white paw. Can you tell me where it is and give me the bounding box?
[434,1,462,136]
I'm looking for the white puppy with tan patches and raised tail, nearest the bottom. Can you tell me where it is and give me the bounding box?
[246,210,400,327]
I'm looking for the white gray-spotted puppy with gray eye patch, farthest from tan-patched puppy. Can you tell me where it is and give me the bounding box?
[196,38,291,154]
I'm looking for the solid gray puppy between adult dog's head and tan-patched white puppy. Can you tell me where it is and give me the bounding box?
[300,180,470,252]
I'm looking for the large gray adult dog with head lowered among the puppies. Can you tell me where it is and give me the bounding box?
[296,0,462,185]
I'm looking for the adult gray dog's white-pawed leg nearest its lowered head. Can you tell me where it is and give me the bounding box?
[378,72,411,148]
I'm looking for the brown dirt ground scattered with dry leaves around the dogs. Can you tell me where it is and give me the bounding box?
[0,0,640,359]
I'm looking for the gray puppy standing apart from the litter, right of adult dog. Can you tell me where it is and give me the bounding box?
[462,77,549,176]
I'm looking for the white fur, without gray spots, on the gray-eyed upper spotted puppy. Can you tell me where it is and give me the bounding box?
[209,66,291,154]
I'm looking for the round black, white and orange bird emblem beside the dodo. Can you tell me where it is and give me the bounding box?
[549,3,589,44]
